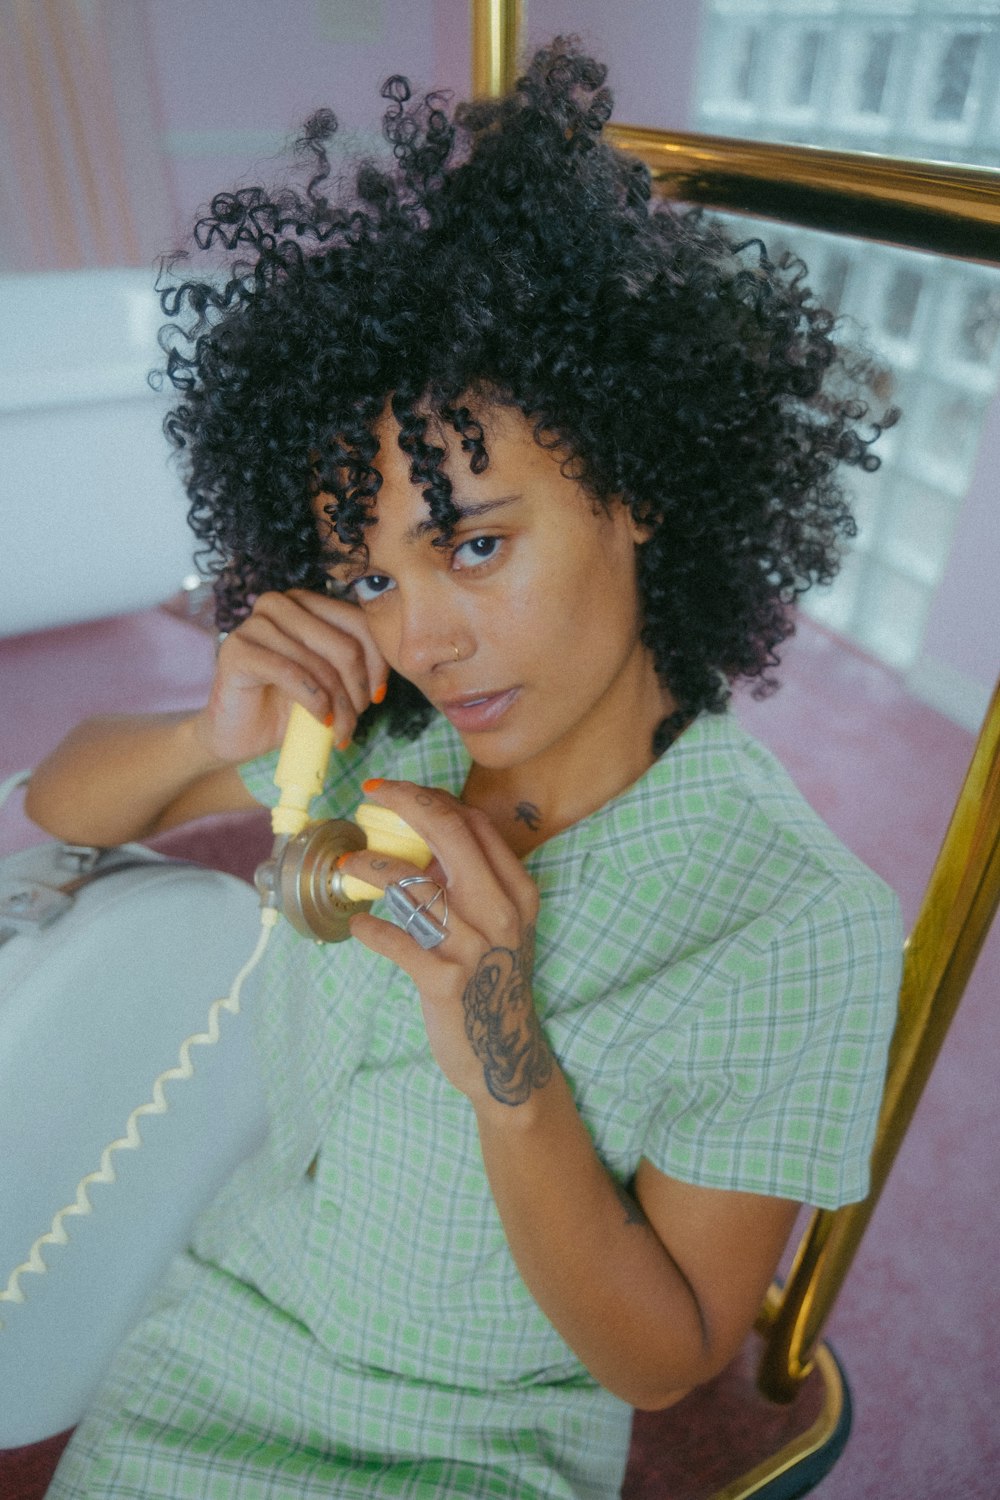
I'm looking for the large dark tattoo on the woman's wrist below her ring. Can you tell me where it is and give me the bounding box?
[462,929,552,1104]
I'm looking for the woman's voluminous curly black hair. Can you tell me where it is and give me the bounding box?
[162,39,892,749]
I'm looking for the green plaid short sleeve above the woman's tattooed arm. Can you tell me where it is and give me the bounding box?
[643,873,903,1208]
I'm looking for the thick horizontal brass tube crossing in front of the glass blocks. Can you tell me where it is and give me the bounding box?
[607,125,1000,264]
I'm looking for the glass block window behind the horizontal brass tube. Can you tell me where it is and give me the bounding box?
[694,0,1000,672]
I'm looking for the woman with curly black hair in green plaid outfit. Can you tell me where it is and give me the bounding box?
[35,44,900,1497]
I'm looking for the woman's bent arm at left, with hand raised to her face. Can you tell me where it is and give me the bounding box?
[25,590,387,845]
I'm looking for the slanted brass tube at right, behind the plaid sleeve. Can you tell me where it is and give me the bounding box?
[759,684,1000,1401]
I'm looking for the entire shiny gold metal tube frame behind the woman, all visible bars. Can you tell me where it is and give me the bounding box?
[471,0,1000,1500]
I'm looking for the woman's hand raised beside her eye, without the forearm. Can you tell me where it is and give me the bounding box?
[195,588,388,764]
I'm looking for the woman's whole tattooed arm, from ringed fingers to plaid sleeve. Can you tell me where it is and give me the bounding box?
[345,782,798,1407]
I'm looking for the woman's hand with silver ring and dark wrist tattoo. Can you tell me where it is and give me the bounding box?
[342,782,553,1106]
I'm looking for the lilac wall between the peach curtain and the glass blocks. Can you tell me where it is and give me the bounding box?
[142,0,699,240]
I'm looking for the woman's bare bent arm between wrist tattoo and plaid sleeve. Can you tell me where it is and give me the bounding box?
[477,1070,798,1409]
